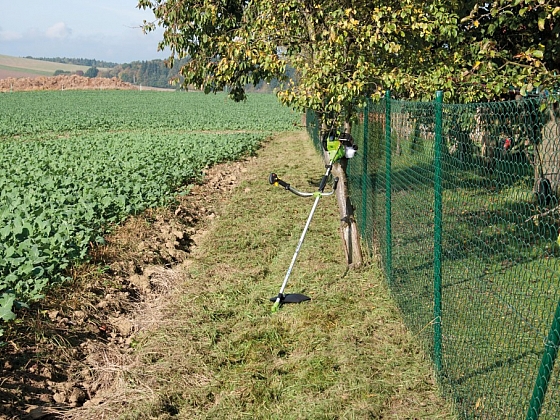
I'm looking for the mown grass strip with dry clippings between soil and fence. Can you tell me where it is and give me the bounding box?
[71,132,455,419]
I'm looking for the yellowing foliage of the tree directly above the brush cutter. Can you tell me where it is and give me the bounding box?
[139,0,458,122]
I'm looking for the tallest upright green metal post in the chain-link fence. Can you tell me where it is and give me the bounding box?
[434,91,443,373]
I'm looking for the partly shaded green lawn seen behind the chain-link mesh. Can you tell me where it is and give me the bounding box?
[360,147,560,413]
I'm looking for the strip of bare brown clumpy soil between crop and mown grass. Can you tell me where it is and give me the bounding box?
[0,161,252,419]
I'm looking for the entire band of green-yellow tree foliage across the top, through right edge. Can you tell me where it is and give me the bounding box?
[139,0,560,116]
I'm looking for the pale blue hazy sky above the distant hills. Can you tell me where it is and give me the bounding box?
[0,0,168,63]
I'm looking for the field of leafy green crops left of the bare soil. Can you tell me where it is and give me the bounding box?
[0,91,297,326]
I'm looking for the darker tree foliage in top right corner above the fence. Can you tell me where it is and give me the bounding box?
[454,0,560,101]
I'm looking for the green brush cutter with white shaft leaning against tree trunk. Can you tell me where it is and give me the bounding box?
[268,131,358,312]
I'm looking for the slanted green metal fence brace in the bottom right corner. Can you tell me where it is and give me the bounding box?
[527,301,560,420]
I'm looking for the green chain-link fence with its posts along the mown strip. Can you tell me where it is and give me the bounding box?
[307,95,560,420]
